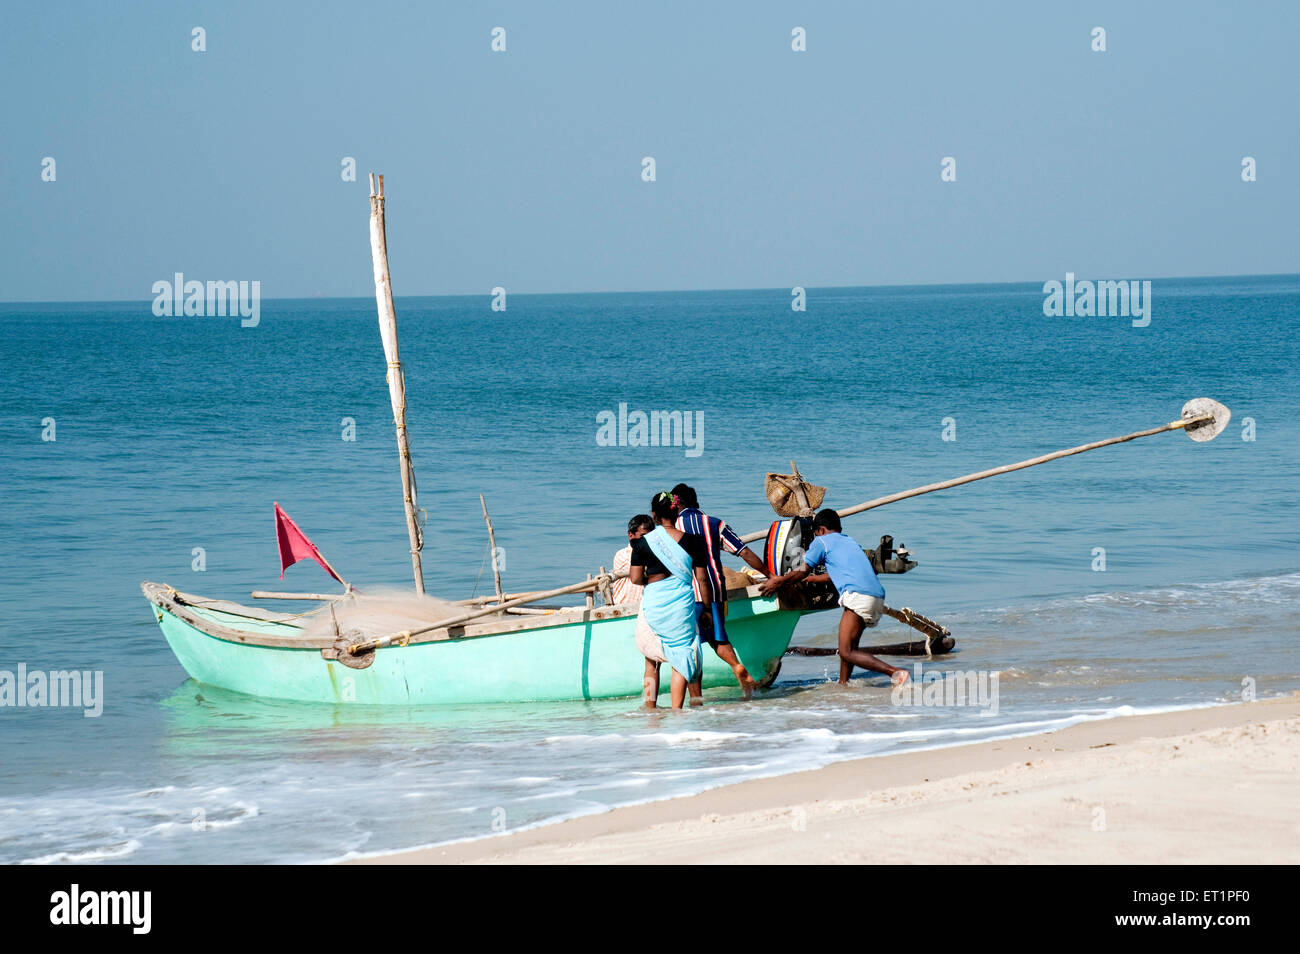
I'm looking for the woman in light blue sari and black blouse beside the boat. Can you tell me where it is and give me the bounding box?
[628,494,711,708]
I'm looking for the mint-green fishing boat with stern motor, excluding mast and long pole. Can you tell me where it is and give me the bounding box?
[140,517,954,706]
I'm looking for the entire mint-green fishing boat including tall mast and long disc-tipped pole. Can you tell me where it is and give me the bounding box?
[140,174,1231,706]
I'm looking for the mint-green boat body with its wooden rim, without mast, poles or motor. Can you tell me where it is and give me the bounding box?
[140,582,801,706]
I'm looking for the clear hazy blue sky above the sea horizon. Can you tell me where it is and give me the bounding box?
[0,0,1300,300]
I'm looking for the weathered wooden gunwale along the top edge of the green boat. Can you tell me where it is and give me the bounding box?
[140,581,764,650]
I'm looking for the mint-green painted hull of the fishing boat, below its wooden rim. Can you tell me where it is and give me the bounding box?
[153,598,800,706]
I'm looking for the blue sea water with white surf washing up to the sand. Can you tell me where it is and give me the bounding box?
[0,276,1300,862]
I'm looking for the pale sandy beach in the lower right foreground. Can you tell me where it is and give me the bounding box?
[354,694,1300,864]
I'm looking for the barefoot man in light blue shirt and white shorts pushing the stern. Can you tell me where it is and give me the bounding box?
[761,509,907,686]
